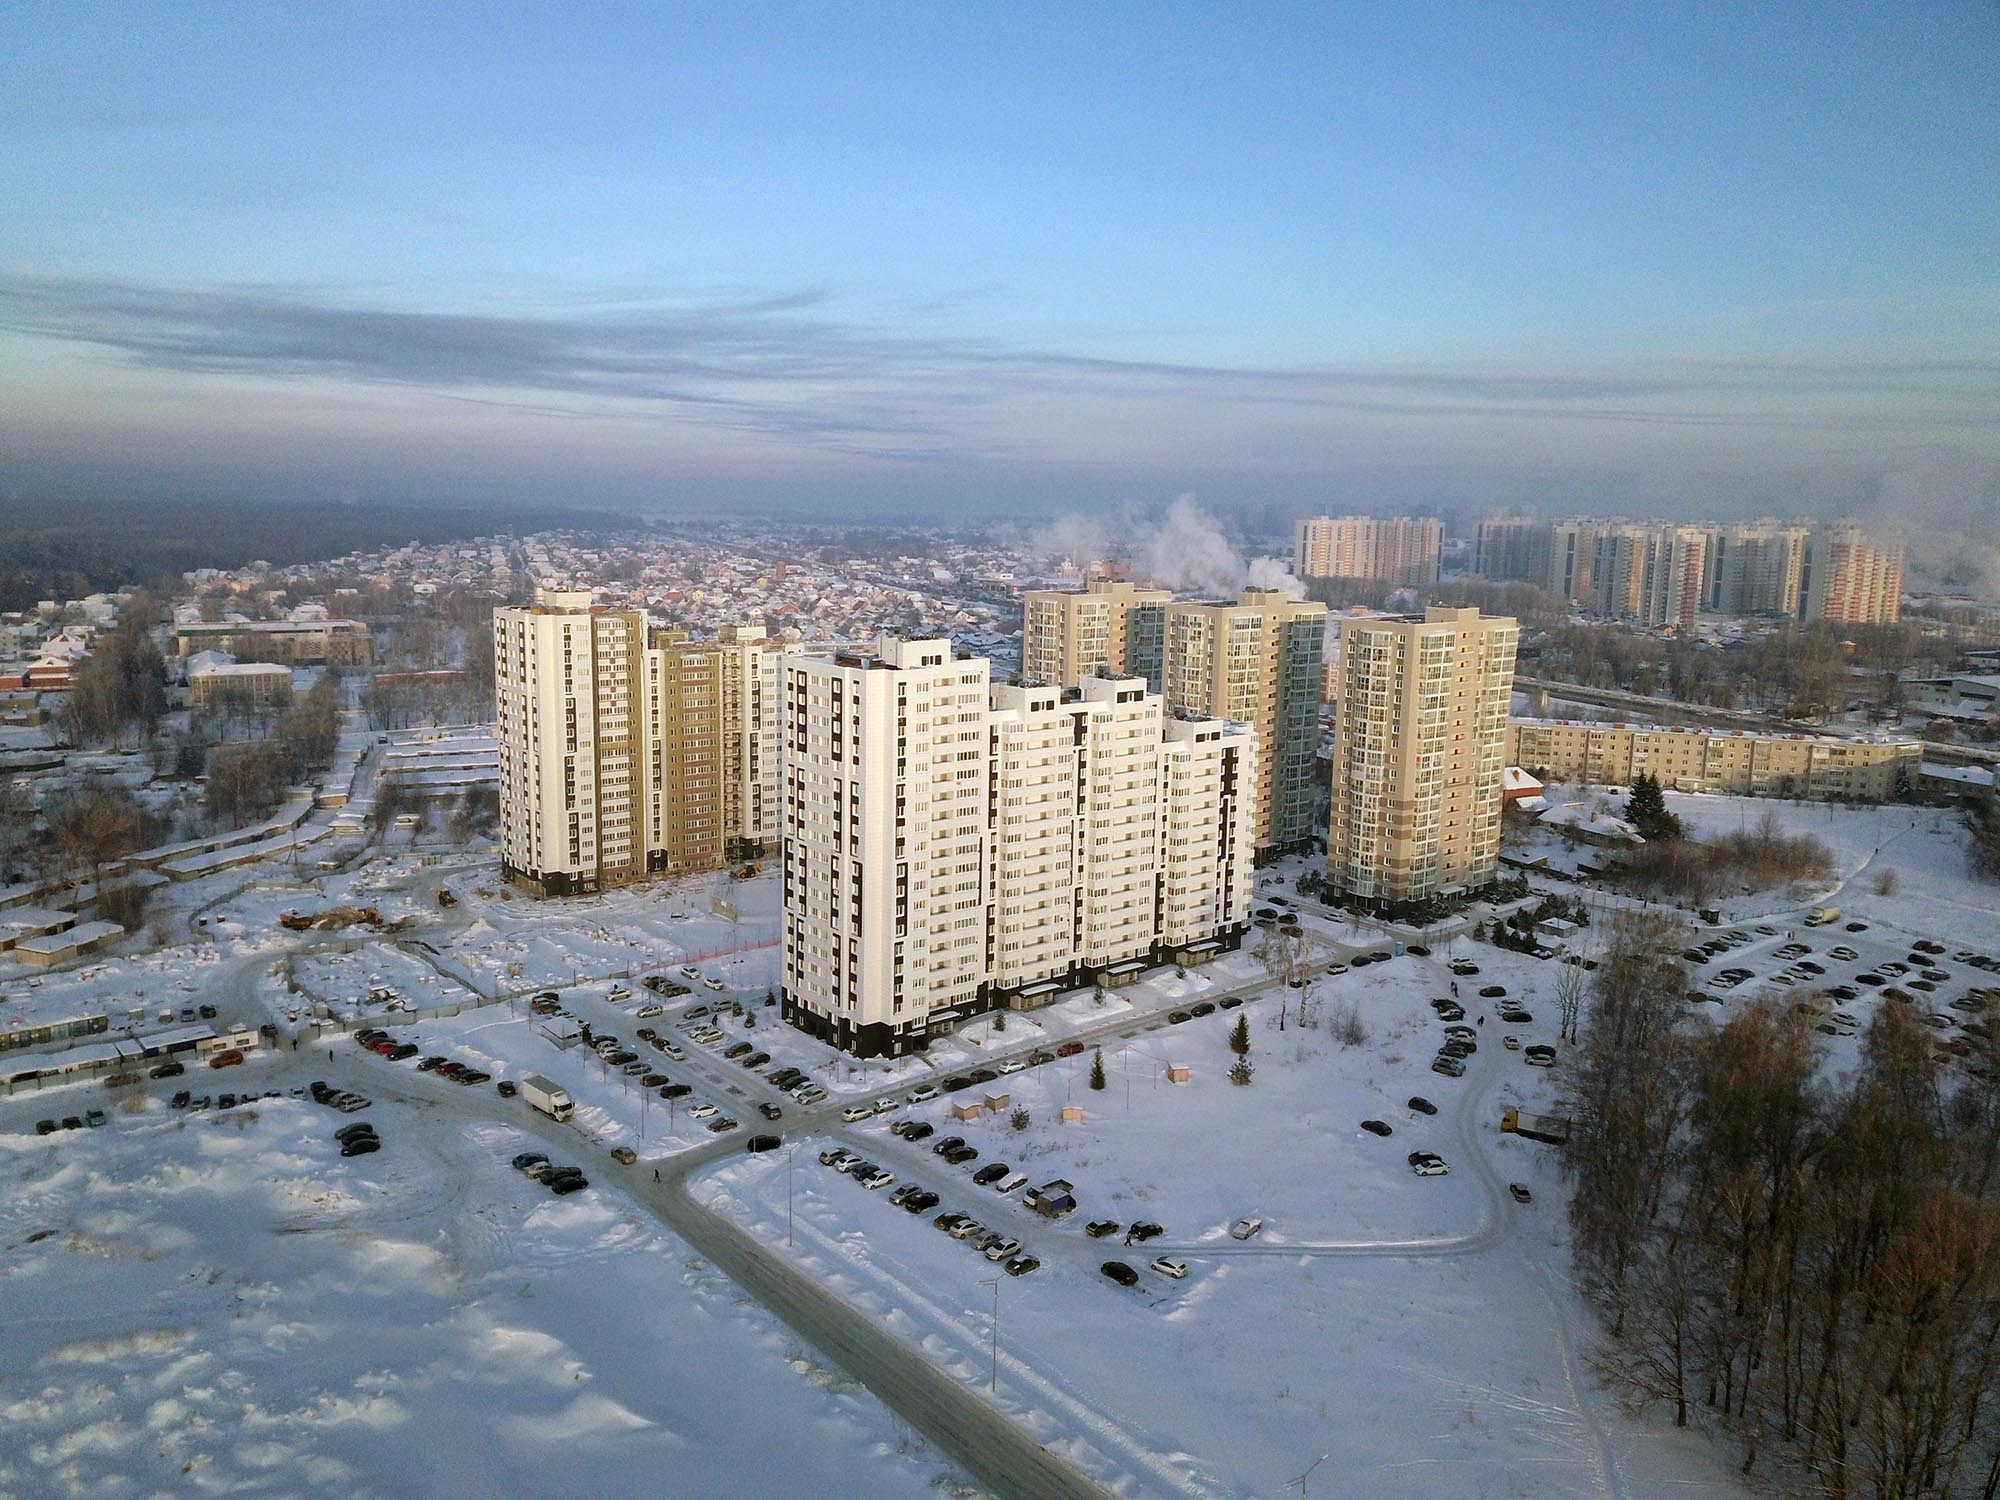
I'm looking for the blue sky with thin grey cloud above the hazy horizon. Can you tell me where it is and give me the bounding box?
[0,0,2000,536]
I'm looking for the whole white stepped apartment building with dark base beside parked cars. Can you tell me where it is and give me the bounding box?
[780,638,1254,1056]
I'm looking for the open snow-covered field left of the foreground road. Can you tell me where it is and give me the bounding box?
[0,1068,962,1500]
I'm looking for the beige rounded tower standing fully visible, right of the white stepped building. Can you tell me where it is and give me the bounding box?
[1326,606,1520,910]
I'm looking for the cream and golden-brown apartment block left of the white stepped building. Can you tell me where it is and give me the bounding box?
[494,588,776,896]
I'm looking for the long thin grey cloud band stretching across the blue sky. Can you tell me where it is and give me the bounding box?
[0,276,2000,460]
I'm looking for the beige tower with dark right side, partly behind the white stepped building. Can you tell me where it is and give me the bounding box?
[1160,588,1326,858]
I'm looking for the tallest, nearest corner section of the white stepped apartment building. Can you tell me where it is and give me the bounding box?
[778,636,992,1056]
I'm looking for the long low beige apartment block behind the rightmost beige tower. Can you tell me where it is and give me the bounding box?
[1506,718,1922,802]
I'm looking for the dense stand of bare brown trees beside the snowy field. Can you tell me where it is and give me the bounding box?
[1564,916,2000,1500]
